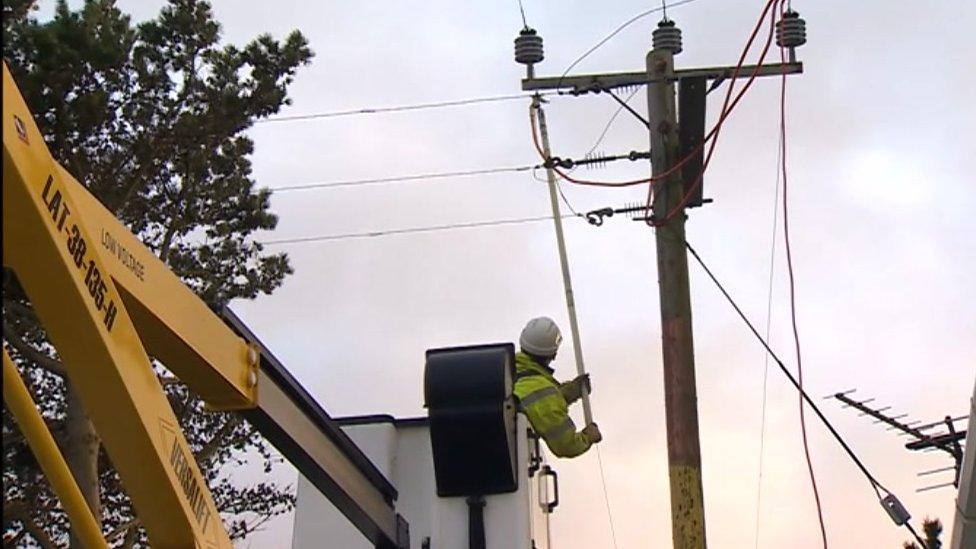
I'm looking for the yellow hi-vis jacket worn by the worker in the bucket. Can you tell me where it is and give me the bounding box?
[515,353,592,457]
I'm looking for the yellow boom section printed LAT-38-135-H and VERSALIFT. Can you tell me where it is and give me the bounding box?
[3,64,233,549]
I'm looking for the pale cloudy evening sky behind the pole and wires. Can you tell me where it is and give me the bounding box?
[40,0,976,549]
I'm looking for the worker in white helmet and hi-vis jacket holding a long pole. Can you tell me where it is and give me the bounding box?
[515,317,603,457]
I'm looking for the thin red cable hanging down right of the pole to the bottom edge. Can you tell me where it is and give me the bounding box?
[779,3,827,549]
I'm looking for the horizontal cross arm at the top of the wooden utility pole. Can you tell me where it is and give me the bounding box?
[522,62,803,94]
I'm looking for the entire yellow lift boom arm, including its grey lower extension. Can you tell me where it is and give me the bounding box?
[3,64,409,548]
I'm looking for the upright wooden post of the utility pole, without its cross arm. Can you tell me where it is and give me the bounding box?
[647,49,705,549]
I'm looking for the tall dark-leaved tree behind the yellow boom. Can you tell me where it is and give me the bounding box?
[2,0,312,547]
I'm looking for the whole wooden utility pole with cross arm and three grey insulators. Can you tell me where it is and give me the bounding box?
[515,10,806,549]
